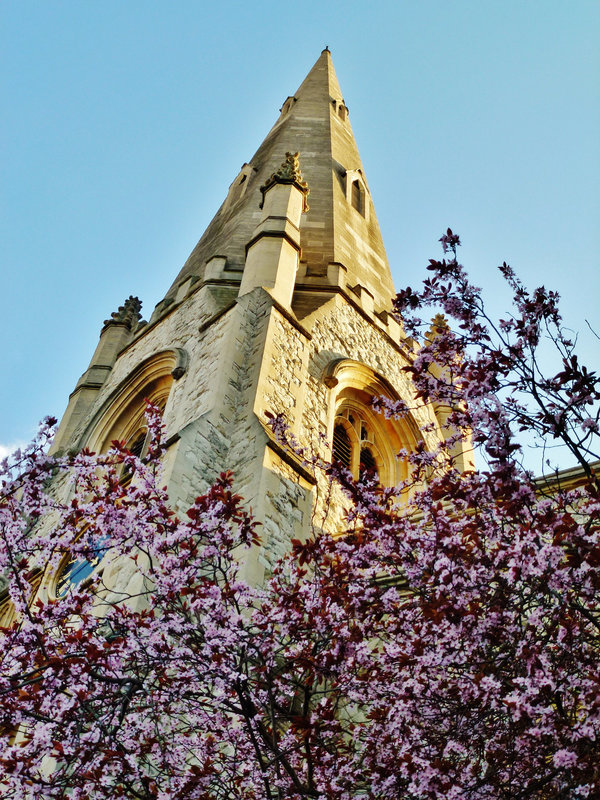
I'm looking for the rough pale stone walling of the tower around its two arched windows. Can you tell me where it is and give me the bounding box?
[48,288,440,580]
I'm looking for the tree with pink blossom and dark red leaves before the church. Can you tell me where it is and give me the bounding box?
[0,230,600,800]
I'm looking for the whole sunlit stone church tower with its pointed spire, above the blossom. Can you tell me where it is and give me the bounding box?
[54,49,464,581]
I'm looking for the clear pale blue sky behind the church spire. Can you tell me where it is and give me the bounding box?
[0,0,600,466]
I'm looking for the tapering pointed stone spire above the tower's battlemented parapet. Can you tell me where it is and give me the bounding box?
[166,49,394,310]
